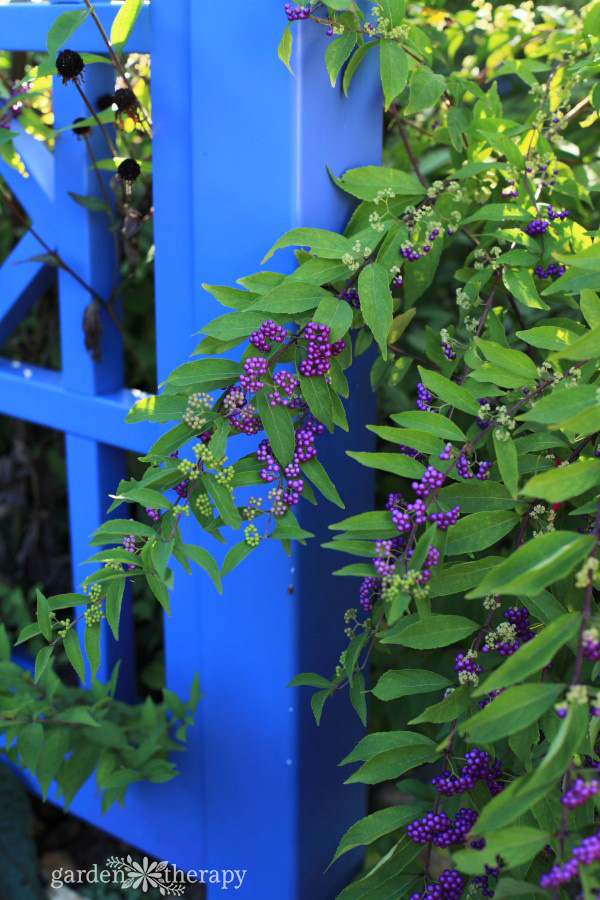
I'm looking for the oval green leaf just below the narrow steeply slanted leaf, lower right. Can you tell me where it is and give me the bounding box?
[458,684,563,744]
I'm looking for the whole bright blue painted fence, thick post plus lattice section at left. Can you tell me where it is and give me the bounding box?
[0,0,381,900]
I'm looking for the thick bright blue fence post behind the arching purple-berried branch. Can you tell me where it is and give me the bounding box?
[151,0,381,900]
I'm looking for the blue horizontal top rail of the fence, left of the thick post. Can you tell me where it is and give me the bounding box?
[0,0,151,53]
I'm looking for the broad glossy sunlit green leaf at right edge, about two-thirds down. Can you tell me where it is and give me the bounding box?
[466,526,594,599]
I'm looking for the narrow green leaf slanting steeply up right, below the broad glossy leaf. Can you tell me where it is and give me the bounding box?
[473,613,581,697]
